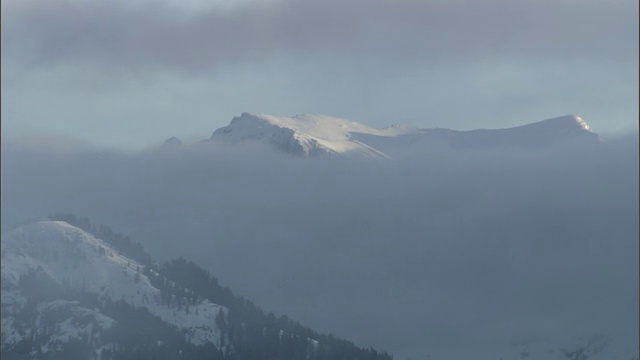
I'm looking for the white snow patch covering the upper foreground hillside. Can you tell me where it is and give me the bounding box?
[2,221,222,345]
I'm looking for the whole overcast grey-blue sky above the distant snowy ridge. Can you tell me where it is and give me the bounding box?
[2,0,638,149]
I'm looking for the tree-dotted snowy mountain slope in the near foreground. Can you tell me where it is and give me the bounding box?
[2,215,390,359]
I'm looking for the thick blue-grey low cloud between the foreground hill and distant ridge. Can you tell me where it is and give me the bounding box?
[2,134,639,359]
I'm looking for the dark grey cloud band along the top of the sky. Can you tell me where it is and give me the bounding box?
[2,0,638,74]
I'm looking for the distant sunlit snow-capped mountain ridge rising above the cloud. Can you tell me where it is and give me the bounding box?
[210,113,598,159]
